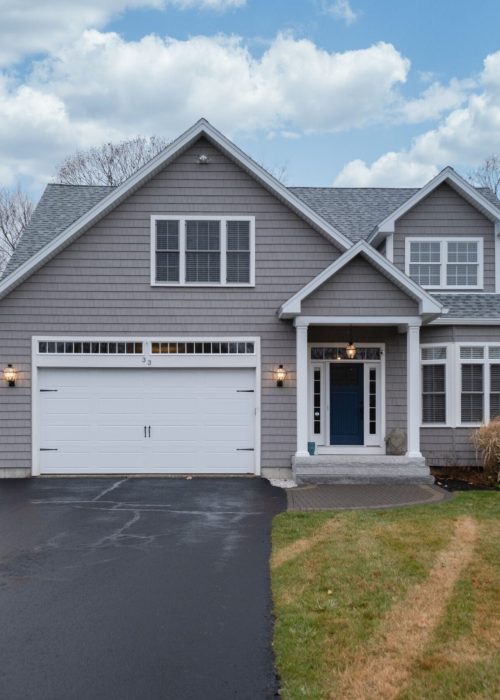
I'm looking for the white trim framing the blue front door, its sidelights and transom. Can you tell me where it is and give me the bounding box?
[307,341,386,455]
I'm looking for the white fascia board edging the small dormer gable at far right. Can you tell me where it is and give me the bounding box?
[368,166,500,243]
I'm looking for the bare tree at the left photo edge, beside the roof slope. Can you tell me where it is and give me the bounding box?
[0,187,34,271]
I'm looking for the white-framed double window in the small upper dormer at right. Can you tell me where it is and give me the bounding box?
[406,238,483,289]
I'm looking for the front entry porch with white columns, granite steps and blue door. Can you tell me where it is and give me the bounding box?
[292,316,432,484]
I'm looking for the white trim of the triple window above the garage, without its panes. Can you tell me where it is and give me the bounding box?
[150,214,255,287]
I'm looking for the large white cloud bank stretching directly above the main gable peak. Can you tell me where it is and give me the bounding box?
[0,30,409,187]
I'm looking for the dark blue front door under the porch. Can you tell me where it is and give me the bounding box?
[330,362,364,445]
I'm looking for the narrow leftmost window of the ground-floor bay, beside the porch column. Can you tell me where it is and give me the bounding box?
[421,346,447,425]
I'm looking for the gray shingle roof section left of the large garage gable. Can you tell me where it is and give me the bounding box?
[3,185,114,277]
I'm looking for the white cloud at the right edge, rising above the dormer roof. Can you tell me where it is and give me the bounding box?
[334,51,500,186]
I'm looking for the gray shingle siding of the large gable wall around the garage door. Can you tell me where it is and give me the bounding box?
[0,138,340,467]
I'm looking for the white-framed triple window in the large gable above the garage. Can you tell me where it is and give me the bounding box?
[151,216,255,287]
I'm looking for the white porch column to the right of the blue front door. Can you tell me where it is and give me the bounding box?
[406,325,422,457]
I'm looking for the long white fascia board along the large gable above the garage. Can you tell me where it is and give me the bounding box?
[0,119,352,298]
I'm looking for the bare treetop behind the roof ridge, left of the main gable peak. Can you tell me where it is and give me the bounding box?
[55,136,168,186]
